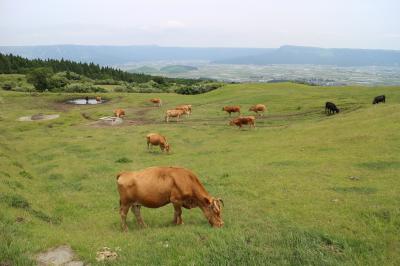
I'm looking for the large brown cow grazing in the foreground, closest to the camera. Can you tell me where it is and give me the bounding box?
[117,167,224,231]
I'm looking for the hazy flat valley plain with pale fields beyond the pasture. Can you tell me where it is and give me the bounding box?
[120,61,400,86]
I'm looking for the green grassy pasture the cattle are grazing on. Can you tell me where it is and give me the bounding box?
[0,83,400,265]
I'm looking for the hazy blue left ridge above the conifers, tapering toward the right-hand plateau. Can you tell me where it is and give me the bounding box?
[0,45,268,65]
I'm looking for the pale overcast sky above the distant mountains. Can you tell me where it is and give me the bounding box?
[0,0,400,50]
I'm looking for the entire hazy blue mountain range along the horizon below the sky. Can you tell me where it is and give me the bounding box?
[0,45,400,66]
